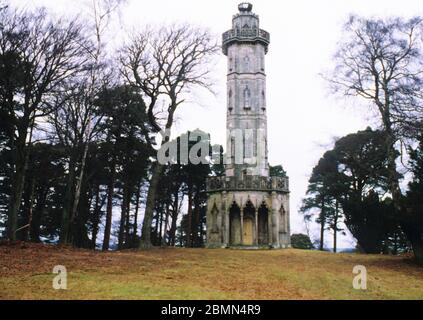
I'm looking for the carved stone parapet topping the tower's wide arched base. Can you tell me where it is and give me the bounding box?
[206,176,289,193]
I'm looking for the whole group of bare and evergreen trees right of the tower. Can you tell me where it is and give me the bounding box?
[302,16,423,263]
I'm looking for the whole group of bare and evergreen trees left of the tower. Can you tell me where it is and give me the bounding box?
[0,0,222,250]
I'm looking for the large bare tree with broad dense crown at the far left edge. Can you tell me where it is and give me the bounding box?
[0,9,89,240]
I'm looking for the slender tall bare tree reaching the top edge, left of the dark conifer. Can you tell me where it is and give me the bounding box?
[52,0,124,243]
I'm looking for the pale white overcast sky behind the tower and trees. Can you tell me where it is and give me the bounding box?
[10,0,423,247]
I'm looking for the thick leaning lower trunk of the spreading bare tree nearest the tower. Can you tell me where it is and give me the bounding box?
[139,162,164,250]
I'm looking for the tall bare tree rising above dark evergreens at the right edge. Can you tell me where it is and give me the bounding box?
[330,16,423,255]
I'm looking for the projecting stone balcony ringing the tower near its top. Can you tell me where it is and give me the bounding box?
[222,28,270,55]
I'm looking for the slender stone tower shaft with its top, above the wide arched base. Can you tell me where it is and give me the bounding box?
[222,2,270,177]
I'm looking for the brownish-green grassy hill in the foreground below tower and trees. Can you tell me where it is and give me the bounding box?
[0,244,423,299]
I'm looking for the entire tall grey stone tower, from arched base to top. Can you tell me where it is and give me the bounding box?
[207,3,290,248]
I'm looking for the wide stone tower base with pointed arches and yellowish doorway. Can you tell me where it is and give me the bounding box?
[207,176,291,249]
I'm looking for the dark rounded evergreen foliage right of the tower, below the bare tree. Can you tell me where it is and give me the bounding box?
[302,128,408,254]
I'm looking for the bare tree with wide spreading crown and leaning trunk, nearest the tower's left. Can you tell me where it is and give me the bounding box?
[121,25,219,249]
